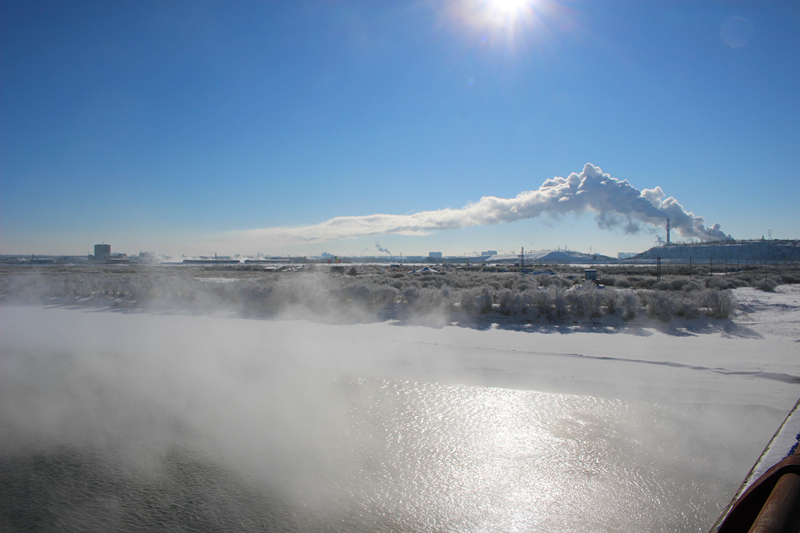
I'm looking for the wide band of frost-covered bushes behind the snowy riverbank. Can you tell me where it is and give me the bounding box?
[0,265,780,324]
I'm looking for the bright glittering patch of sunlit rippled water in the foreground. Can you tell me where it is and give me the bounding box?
[328,379,719,531]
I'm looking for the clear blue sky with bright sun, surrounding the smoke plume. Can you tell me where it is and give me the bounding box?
[0,0,800,255]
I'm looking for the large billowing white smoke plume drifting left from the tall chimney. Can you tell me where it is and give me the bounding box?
[246,163,731,243]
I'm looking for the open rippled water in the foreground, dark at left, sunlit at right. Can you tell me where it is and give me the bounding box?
[0,378,752,532]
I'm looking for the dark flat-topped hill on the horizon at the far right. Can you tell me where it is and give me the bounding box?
[632,240,800,262]
